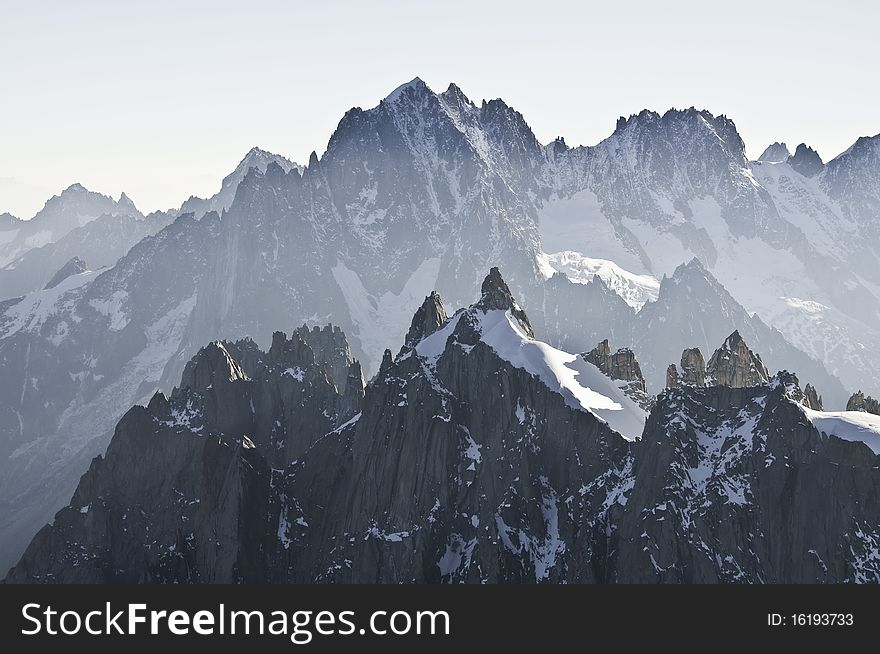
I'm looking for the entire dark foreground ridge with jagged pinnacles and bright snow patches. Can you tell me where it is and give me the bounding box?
[6,269,880,583]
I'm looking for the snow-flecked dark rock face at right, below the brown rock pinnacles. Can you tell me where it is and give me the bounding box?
[608,374,880,583]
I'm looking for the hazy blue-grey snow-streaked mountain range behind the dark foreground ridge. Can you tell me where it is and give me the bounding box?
[0,79,880,578]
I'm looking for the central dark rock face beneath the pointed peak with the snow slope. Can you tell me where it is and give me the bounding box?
[287,314,629,583]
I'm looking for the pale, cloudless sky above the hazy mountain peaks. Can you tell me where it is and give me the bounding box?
[0,0,880,218]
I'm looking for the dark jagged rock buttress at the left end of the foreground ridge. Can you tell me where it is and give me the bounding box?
[8,328,363,583]
